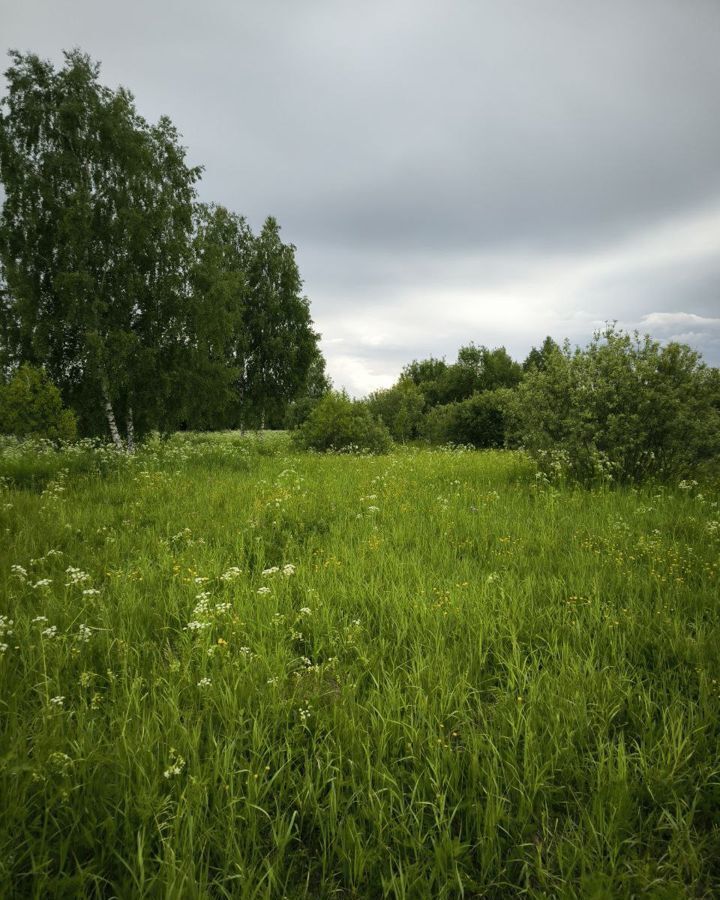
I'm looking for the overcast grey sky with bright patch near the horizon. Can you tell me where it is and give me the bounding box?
[0,0,720,396]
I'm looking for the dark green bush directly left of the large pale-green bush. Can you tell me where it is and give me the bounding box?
[422,388,512,449]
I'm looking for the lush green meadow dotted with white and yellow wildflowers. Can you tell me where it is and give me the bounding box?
[0,435,720,898]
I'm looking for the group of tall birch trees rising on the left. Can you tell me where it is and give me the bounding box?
[0,50,328,449]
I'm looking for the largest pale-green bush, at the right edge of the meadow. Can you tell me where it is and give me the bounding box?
[515,328,720,483]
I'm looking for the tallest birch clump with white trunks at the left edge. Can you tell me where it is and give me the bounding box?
[0,50,200,450]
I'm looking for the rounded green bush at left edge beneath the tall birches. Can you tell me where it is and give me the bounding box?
[0,364,77,441]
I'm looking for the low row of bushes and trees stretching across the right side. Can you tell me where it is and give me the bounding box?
[296,325,720,484]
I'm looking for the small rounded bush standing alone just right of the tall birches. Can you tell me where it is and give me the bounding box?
[293,392,392,453]
